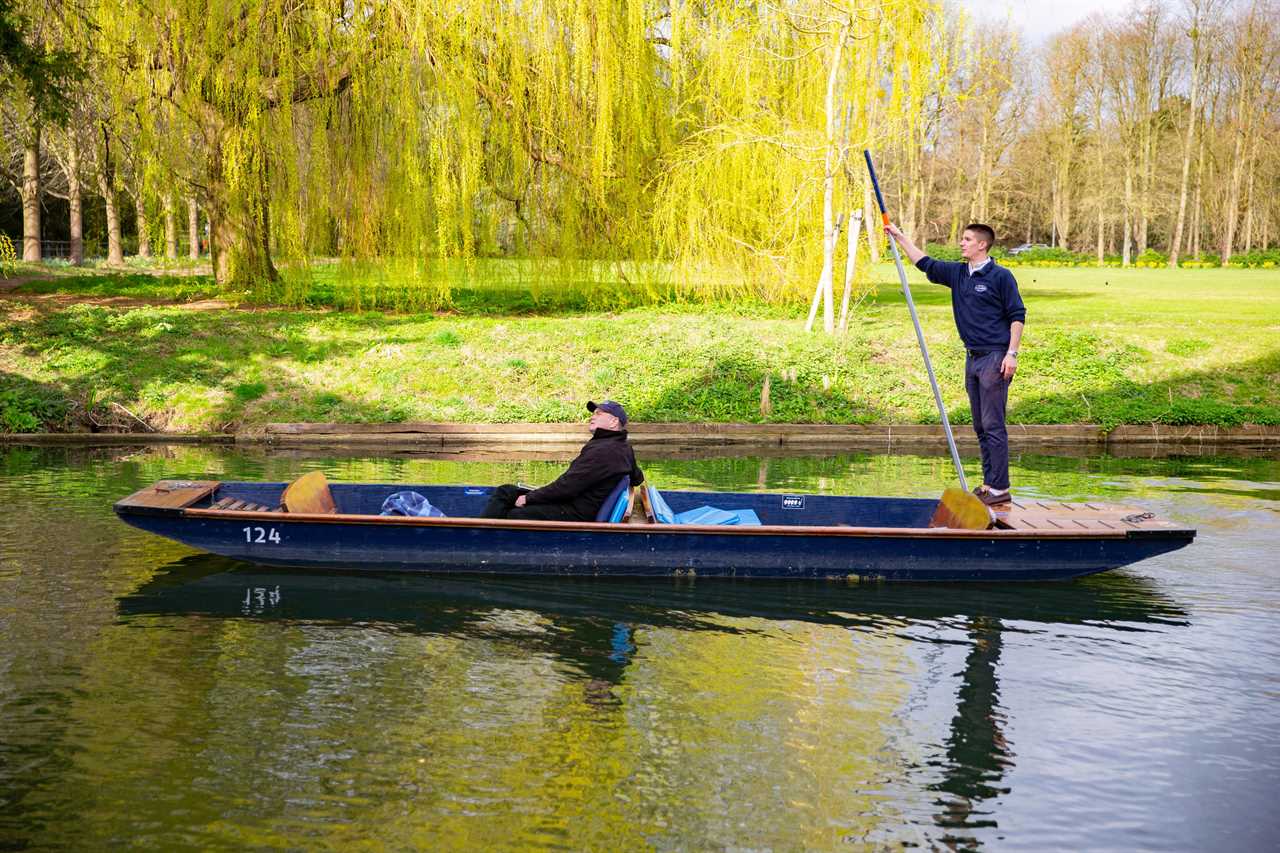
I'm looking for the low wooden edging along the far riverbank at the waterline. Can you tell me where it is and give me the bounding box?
[0,423,1280,452]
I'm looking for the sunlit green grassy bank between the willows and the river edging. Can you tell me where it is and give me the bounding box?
[0,266,1280,432]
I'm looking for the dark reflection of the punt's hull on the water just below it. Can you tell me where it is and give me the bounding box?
[118,555,1185,645]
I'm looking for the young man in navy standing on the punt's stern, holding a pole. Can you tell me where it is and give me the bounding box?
[884,223,1027,505]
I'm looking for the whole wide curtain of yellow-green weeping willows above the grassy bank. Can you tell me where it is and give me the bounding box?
[97,0,962,307]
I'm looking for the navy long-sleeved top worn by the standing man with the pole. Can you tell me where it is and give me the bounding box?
[915,255,1027,351]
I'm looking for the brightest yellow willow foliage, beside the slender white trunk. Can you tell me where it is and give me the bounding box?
[655,0,941,301]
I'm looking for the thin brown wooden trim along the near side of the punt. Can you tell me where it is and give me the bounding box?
[170,508,1192,539]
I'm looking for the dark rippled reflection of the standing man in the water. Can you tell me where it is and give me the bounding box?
[931,617,1012,849]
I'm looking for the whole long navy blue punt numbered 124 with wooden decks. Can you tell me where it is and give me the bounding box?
[115,473,1196,581]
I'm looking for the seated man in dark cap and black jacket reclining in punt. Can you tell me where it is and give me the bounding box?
[483,400,644,521]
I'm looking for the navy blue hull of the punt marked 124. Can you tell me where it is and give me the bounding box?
[116,484,1194,581]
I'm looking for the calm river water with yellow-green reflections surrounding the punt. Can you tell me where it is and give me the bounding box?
[0,447,1280,852]
